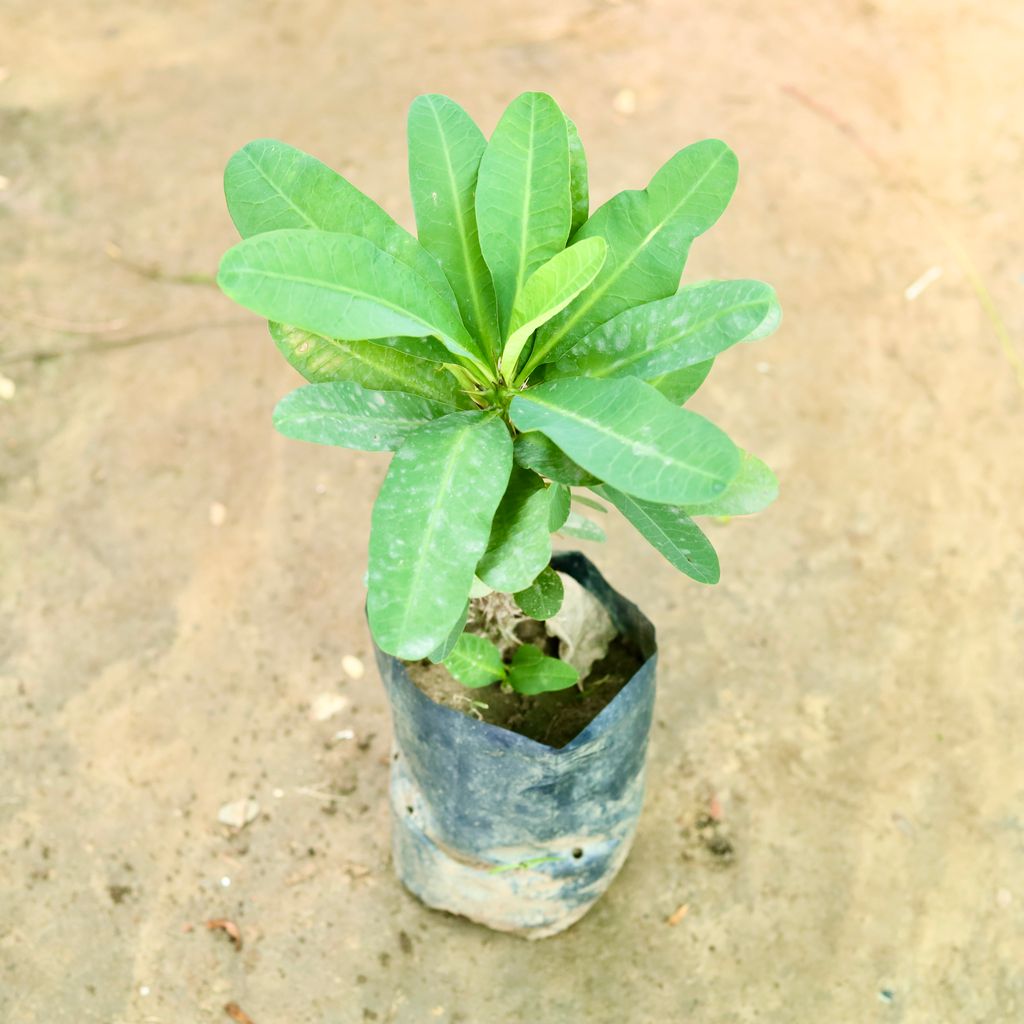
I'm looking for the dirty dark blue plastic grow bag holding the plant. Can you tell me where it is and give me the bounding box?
[377,552,657,938]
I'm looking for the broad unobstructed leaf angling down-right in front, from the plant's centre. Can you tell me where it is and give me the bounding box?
[510,377,739,505]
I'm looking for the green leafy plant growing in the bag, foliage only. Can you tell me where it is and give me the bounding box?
[218,92,779,693]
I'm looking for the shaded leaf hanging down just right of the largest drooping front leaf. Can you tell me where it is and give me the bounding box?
[476,466,551,594]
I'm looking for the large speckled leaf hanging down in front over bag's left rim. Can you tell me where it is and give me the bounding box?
[367,412,512,660]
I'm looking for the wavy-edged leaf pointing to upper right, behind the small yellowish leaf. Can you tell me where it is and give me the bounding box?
[520,139,737,379]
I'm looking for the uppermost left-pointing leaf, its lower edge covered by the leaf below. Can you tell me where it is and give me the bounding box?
[224,138,455,306]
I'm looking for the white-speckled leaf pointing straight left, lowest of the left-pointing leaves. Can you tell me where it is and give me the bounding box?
[273,381,454,452]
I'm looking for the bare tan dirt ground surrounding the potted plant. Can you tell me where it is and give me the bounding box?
[0,0,1024,1024]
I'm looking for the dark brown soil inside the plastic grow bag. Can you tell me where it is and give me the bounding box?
[406,636,644,748]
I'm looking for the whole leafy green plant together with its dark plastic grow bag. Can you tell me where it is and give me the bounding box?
[218,92,779,938]
